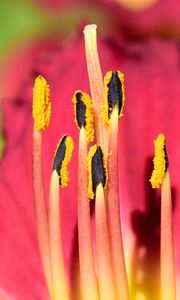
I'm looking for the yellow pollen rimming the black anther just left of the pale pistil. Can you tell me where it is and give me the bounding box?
[72,90,94,142]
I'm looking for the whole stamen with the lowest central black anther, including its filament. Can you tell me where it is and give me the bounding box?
[88,145,116,300]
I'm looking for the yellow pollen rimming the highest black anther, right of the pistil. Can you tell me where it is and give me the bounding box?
[101,71,125,123]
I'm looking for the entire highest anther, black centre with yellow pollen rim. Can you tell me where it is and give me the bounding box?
[102,71,125,123]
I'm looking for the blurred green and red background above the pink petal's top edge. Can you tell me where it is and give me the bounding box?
[0,0,180,159]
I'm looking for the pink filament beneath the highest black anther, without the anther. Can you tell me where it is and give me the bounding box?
[107,105,129,300]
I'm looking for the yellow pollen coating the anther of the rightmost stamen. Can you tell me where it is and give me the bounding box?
[149,133,166,189]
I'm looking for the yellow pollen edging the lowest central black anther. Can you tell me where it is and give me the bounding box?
[87,145,108,199]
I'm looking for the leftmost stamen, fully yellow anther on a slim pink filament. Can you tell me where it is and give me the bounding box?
[32,76,53,299]
